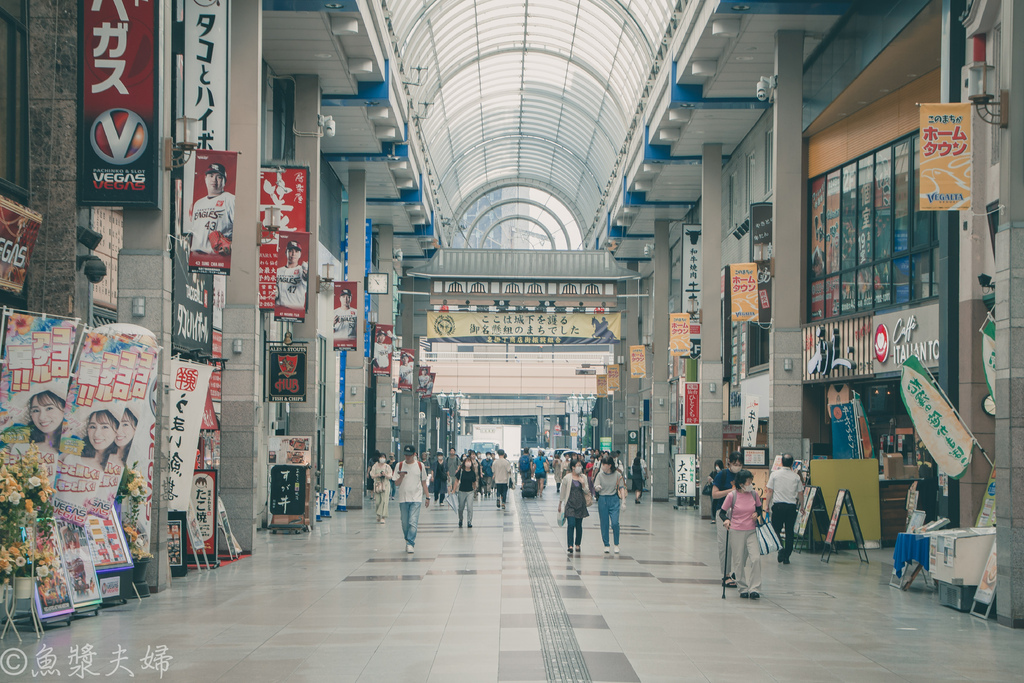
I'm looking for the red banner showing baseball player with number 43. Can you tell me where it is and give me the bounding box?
[184,150,239,275]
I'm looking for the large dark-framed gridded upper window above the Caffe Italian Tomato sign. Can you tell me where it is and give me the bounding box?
[808,134,938,322]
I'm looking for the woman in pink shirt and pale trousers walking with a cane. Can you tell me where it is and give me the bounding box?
[719,470,761,600]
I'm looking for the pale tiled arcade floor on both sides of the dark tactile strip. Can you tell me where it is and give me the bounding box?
[6,495,1024,683]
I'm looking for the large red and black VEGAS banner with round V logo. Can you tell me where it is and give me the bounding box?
[78,1,162,208]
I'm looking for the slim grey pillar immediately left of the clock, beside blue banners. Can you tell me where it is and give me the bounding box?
[343,170,367,510]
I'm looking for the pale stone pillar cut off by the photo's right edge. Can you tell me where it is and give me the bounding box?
[995,2,1024,629]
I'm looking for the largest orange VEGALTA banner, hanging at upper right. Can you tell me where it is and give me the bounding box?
[918,102,971,211]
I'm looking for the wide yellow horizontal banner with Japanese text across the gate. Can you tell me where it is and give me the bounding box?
[427,311,622,344]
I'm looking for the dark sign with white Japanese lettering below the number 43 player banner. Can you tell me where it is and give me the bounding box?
[171,244,214,355]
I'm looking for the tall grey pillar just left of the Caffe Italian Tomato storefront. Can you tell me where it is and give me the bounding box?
[770,31,807,458]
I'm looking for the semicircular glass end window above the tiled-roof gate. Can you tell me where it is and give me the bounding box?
[452,186,583,249]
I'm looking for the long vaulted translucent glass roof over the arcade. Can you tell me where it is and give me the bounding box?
[386,0,675,248]
